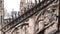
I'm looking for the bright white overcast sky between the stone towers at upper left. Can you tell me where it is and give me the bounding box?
[4,0,20,13]
